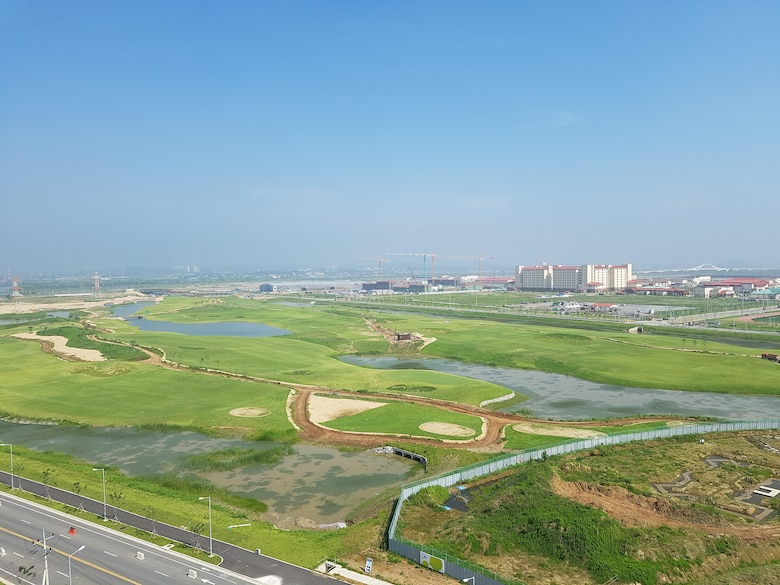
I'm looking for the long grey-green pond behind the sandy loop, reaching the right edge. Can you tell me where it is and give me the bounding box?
[341,356,780,420]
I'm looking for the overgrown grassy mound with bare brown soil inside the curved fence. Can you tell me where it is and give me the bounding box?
[403,434,780,585]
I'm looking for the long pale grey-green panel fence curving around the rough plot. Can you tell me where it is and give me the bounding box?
[387,419,780,585]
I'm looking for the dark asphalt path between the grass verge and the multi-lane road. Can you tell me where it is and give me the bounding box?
[0,471,344,585]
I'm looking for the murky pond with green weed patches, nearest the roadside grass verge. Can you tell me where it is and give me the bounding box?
[0,421,414,528]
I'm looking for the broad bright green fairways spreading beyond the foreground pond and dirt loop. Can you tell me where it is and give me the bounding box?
[0,298,780,434]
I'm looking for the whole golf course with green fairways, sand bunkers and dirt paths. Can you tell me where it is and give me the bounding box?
[0,295,780,585]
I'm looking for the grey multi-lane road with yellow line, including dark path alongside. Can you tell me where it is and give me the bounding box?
[0,472,348,585]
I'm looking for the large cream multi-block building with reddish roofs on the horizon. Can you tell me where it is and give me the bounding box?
[515,264,633,292]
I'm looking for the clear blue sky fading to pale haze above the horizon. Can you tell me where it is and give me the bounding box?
[0,0,780,273]
